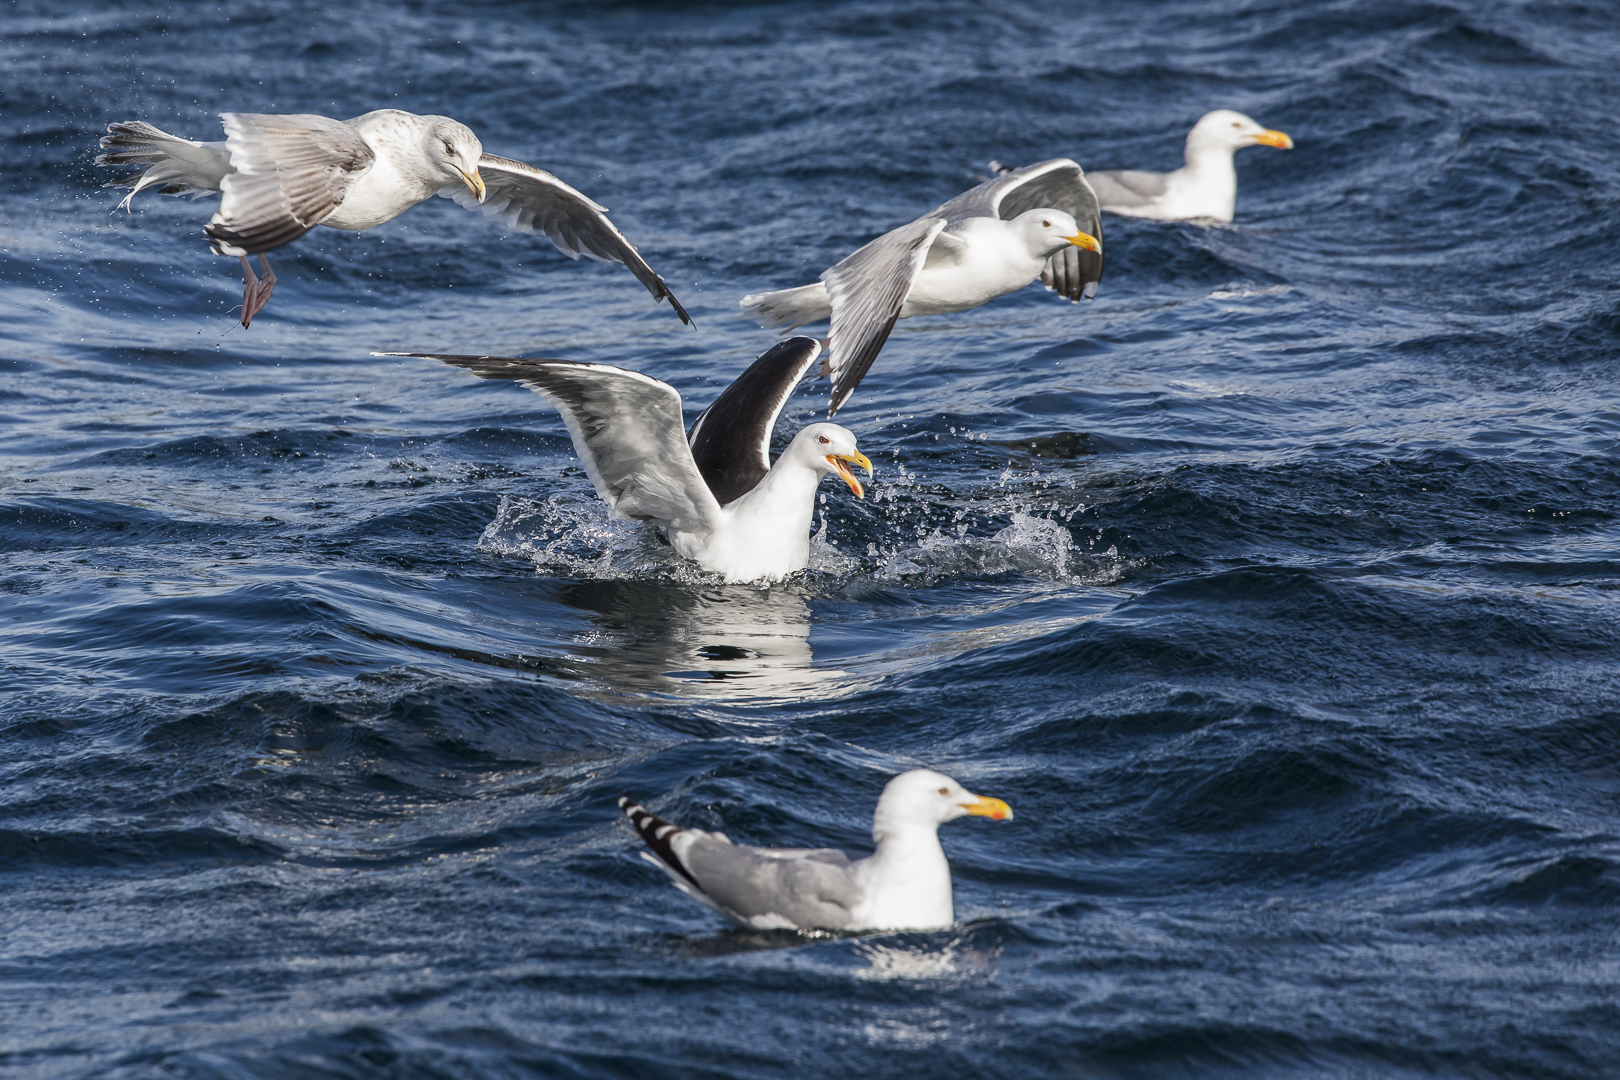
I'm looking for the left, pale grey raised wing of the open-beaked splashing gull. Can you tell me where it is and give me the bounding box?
[392,353,719,533]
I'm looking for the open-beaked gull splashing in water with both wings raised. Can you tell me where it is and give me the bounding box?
[373,337,872,581]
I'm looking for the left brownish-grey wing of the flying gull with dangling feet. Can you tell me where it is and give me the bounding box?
[203,112,376,254]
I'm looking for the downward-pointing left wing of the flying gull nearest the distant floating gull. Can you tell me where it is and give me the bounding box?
[821,212,946,418]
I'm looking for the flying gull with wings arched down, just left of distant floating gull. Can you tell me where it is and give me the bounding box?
[740,157,1103,418]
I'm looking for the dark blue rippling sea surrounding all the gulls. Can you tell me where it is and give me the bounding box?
[0,0,1620,1080]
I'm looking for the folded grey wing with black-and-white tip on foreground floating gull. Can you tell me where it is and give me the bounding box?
[619,798,860,929]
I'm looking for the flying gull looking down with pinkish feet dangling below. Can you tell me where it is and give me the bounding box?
[96,108,692,327]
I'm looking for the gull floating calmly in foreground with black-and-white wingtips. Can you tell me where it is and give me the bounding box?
[619,769,1013,929]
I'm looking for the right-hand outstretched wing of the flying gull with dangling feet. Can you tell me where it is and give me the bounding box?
[439,154,692,325]
